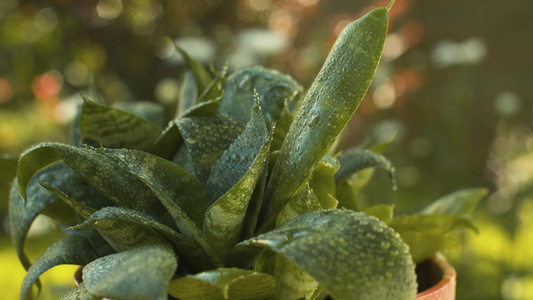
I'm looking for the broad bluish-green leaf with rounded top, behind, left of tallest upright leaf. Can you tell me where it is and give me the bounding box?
[218,66,303,128]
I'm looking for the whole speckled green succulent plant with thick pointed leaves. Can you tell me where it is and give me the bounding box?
[4,3,485,300]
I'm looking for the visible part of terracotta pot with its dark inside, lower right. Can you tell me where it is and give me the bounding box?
[74,257,457,300]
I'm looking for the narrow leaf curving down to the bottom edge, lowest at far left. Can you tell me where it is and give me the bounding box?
[20,235,98,300]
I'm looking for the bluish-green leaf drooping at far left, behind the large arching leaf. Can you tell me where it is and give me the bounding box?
[9,163,76,269]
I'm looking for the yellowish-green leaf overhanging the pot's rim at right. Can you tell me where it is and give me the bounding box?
[389,215,477,262]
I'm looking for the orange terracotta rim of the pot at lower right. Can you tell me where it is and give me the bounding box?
[416,256,457,300]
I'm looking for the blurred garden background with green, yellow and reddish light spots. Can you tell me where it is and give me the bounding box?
[0,0,533,300]
